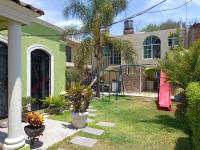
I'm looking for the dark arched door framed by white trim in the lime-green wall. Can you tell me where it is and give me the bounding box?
[31,49,51,109]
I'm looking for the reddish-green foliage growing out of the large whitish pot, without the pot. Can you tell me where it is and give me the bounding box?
[66,84,93,113]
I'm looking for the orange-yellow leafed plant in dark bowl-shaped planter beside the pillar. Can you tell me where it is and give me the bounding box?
[24,112,45,143]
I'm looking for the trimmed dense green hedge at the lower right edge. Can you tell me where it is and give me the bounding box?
[186,82,200,150]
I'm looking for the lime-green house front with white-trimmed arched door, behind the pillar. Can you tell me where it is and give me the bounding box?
[0,19,65,117]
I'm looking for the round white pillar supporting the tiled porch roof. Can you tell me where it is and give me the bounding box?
[4,21,25,149]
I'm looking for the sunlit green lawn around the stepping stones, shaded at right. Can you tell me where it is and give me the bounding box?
[49,97,192,150]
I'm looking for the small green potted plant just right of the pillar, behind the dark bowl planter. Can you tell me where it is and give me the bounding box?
[22,97,36,122]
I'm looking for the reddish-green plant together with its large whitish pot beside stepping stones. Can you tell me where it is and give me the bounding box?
[66,84,93,129]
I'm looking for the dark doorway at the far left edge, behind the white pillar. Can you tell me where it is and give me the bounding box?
[0,42,8,118]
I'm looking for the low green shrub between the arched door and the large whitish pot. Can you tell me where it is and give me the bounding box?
[42,95,67,113]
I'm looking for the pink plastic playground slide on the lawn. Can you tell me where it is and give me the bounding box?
[159,71,172,110]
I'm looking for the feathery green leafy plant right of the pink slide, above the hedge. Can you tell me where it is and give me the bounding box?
[159,41,200,93]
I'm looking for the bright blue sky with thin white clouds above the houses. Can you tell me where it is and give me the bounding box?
[21,0,200,35]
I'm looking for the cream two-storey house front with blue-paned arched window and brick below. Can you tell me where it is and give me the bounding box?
[99,24,181,93]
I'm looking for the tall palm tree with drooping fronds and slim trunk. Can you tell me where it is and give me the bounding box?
[64,0,135,97]
